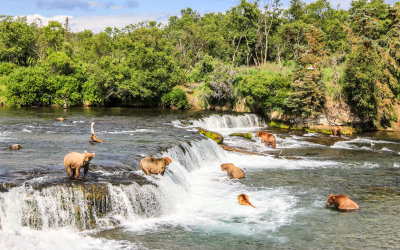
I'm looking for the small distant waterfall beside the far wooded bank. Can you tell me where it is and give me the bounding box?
[193,114,263,130]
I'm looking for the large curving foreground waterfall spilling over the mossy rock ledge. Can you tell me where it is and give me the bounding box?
[0,140,224,230]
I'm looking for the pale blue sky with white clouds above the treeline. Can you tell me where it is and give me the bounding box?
[0,0,396,32]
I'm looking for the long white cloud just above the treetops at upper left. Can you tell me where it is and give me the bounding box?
[21,12,173,33]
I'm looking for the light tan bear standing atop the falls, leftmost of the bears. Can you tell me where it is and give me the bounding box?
[64,151,95,179]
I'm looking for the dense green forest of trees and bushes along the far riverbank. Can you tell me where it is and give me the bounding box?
[0,0,400,127]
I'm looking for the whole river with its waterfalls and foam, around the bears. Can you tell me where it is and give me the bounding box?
[0,108,400,249]
